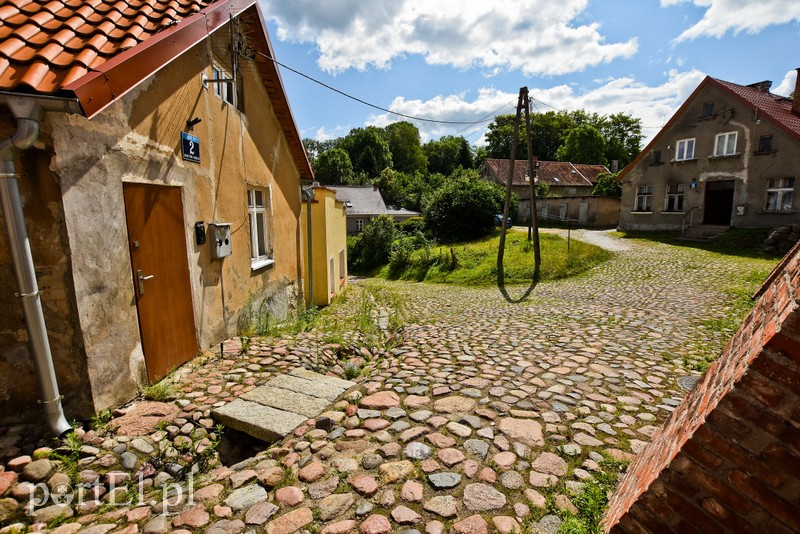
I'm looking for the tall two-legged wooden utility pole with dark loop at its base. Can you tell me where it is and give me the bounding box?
[497,87,542,303]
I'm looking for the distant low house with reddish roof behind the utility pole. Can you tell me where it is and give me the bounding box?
[478,158,619,227]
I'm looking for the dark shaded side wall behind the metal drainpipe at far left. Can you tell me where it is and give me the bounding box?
[0,115,91,422]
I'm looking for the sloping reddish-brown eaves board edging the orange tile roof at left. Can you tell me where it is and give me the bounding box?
[64,0,257,118]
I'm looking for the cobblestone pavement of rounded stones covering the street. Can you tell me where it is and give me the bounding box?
[0,234,774,534]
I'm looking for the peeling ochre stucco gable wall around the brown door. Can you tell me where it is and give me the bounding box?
[0,25,302,417]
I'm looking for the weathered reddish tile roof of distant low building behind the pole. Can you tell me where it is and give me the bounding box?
[486,159,608,187]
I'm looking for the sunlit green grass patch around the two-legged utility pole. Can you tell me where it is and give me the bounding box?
[379,232,613,286]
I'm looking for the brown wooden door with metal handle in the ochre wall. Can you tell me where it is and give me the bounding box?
[123,183,198,383]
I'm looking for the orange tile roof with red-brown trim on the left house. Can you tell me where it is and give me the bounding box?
[0,0,313,180]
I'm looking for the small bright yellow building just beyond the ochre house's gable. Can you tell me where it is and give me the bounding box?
[303,186,347,306]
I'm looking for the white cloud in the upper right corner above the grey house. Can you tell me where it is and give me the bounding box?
[661,0,800,41]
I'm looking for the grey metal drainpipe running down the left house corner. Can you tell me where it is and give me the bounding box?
[0,95,72,437]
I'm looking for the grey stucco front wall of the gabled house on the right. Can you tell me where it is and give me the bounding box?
[619,85,800,230]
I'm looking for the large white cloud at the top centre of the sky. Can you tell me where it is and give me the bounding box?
[261,0,638,75]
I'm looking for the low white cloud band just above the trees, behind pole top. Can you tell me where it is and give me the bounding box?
[369,70,705,146]
